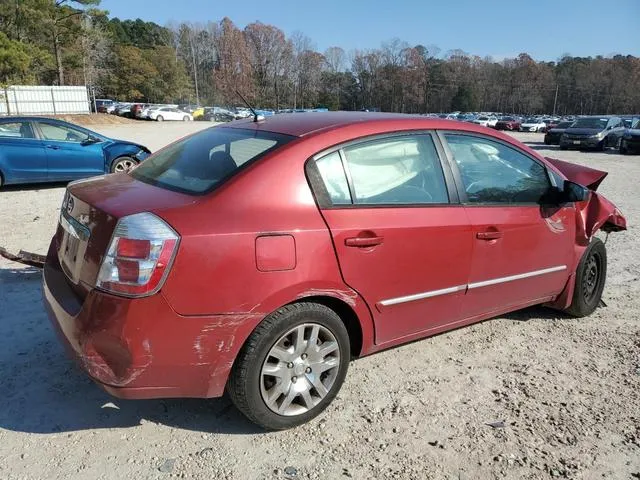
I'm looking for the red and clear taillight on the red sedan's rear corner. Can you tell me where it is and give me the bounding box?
[96,212,180,297]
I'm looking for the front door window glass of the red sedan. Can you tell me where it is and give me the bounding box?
[445,134,550,204]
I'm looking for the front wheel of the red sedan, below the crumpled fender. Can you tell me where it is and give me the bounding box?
[566,238,607,317]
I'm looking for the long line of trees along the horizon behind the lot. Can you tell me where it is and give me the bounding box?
[0,0,640,114]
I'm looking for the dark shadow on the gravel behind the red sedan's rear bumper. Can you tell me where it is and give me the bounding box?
[0,267,264,435]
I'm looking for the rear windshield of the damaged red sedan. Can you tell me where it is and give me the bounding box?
[131,127,295,195]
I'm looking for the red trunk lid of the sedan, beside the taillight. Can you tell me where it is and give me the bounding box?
[56,174,196,298]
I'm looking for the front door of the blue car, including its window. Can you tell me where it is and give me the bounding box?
[36,120,105,181]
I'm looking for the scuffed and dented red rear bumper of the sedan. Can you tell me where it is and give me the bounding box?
[43,240,259,399]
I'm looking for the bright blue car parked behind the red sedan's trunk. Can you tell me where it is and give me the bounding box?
[0,117,151,187]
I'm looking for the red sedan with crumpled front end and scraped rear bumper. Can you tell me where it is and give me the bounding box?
[44,113,626,429]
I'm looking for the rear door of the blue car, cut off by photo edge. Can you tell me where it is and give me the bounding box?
[0,121,47,183]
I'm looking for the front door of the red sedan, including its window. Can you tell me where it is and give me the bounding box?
[441,132,575,318]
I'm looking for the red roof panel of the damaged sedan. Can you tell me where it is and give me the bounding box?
[225,112,482,137]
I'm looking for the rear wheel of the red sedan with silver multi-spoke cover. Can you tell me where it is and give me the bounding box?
[227,303,350,430]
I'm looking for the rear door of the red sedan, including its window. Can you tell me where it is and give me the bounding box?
[308,133,472,344]
